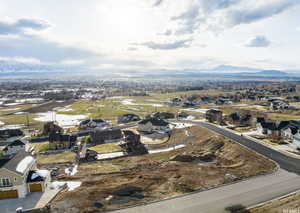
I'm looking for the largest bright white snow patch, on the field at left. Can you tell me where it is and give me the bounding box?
[34,111,87,127]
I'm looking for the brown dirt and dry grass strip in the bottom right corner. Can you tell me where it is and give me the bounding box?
[249,192,300,213]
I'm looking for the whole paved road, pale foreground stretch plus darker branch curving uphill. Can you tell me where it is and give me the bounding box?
[113,122,300,213]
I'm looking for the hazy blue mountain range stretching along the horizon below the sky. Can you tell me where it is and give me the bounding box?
[0,60,300,78]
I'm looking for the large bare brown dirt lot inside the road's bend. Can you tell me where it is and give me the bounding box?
[52,127,275,213]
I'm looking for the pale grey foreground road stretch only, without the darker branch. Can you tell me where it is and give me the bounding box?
[113,169,300,213]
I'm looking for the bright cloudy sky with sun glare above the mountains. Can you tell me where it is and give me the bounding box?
[0,0,300,72]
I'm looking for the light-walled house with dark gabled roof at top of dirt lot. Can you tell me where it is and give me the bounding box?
[138,118,170,133]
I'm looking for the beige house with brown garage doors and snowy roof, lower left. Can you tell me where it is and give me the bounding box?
[0,151,50,199]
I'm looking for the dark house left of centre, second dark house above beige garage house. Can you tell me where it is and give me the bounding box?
[49,132,77,150]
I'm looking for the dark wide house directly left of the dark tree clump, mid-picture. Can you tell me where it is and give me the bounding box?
[90,129,124,144]
